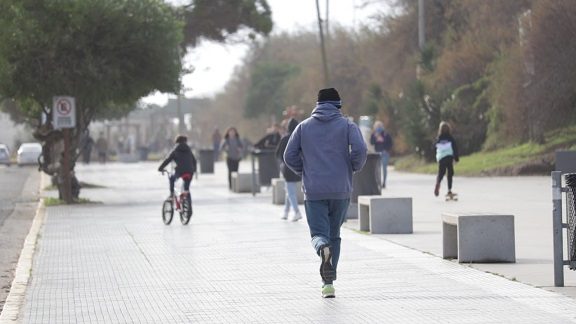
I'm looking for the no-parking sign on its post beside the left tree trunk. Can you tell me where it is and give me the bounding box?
[52,97,76,204]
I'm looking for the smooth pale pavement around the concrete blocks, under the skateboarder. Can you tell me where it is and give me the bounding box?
[345,170,576,298]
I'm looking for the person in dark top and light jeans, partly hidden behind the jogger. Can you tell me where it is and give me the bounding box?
[276,118,302,222]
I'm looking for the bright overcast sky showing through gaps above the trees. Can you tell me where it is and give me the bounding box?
[144,0,382,105]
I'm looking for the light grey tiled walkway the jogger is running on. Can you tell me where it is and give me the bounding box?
[10,162,576,323]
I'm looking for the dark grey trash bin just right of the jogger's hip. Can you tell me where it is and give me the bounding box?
[347,153,382,218]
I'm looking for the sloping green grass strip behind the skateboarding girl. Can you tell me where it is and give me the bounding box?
[394,126,576,176]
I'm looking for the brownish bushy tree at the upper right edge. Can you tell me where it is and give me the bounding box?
[521,0,576,142]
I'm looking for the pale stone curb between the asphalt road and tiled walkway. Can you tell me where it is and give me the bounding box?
[0,176,46,324]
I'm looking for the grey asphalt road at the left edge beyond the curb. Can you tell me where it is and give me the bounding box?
[0,166,40,310]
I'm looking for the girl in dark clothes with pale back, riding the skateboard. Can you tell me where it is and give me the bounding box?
[434,121,459,199]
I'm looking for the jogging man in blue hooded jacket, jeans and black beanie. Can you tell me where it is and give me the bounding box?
[284,88,366,298]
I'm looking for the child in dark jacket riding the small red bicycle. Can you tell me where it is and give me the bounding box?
[158,135,196,196]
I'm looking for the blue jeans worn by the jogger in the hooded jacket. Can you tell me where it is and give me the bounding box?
[304,199,350,271]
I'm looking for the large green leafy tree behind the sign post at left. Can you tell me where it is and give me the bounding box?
[0,0,183,200]
